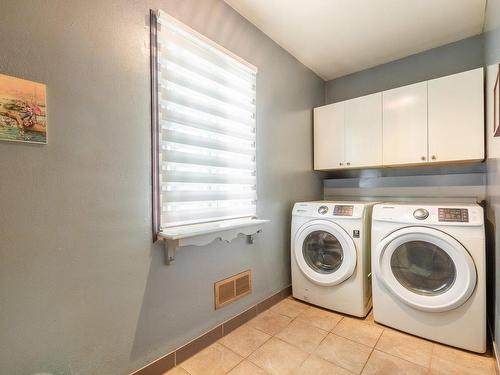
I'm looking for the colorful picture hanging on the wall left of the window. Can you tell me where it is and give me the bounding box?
[0,74,47,144]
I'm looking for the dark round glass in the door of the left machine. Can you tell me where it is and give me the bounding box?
[302,230,344,274]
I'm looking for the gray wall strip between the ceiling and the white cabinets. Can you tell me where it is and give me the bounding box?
[325,35,483,104]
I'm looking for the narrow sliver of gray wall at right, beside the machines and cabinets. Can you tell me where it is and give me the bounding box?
[484,0,500,368]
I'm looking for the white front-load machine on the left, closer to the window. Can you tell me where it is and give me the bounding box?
[291,201,374,317]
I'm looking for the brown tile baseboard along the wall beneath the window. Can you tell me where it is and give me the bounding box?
[131,285,292,375]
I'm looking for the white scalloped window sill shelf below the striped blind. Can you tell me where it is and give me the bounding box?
[158,218,269,264]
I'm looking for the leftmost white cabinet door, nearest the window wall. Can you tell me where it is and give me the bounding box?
[314,102,345,169]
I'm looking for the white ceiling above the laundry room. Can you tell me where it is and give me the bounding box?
[225,0,486,80]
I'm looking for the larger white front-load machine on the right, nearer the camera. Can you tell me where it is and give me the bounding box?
[372,203,486,353]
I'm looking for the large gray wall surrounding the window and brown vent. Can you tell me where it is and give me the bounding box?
[0,0,324,375]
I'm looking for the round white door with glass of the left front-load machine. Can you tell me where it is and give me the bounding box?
[295,220,356,286]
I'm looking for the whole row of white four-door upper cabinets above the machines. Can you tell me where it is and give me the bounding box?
[314,68,484,170]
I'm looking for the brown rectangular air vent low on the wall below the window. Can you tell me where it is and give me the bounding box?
[214,270,252,309]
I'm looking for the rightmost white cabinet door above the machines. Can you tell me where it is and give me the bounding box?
[428,68,484,163]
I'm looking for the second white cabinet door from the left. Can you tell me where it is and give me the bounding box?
[345,92,382,167]
